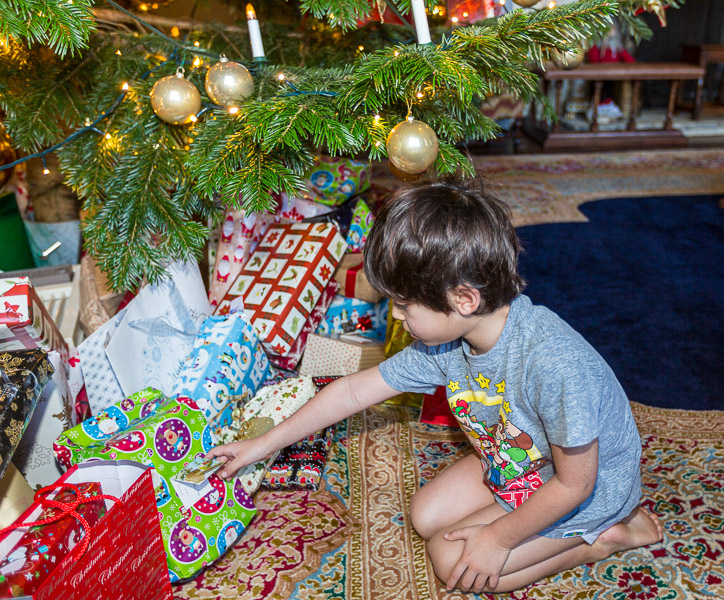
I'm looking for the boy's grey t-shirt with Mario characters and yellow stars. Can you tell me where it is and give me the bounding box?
[380,296,641,542]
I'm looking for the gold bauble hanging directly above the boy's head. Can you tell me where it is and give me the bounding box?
[387,116,439,177]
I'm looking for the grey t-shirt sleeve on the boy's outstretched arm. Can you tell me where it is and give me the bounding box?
[380,341,452,394]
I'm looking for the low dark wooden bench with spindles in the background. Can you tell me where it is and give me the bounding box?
[525,63,704,152]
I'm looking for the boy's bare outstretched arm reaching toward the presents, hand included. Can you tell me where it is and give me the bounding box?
[206,367,400,478]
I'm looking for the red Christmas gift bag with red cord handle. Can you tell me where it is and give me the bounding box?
[0,460,173,600]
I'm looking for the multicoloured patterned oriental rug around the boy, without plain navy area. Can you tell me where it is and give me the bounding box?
[175,150,724,600]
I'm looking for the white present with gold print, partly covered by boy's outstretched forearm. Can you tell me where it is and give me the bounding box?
[211,377,317,495]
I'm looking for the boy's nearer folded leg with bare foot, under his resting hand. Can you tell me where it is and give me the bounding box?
[428,505,663,592]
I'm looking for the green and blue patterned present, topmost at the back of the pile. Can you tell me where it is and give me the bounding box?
[306,156,370,206]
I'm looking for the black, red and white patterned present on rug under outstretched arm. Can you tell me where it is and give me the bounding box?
[261,426,334,491]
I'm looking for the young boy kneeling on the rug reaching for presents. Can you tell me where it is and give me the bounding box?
[209,177,662,593]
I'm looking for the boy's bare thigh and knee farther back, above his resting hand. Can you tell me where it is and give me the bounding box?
[410,454,502,540]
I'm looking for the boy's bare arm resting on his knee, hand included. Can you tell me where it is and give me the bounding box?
[445,439,598,589]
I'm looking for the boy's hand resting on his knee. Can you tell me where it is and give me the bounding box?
[445,525,511,594]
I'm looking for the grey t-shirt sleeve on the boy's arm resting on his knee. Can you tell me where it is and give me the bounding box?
[526,337,606,448]
